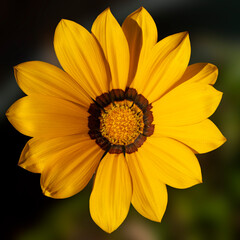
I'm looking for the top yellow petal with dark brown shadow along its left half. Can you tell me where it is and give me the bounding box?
[122,7,158,85]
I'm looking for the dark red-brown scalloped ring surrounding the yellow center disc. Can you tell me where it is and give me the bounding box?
[88,88,154,154]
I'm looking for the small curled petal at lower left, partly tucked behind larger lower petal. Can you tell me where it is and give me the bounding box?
[18,134,92,173]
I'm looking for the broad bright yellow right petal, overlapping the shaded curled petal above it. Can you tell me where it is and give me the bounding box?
[153,83,222,126]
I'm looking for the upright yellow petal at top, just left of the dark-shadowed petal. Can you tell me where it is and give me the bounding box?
[92,8,130,90]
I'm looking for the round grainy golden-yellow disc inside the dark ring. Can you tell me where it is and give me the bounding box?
[99,100,144,145]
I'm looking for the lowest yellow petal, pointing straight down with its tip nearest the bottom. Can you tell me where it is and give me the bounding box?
[90,154,132,233]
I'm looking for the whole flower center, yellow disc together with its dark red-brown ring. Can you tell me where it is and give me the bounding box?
[88,88,154,154]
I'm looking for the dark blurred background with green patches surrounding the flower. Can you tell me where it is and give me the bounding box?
[0,0,240,240]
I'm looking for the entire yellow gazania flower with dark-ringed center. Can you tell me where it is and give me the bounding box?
[7,8,225,232]
